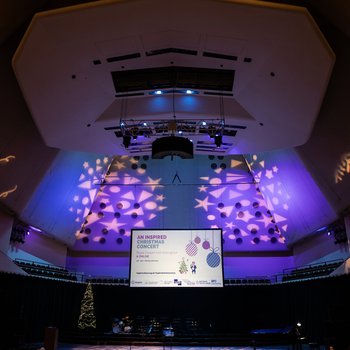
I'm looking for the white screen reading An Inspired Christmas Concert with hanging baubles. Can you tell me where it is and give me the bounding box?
[129,229,223,287]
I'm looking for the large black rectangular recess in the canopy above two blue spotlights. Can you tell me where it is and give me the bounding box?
[111,66,235,93]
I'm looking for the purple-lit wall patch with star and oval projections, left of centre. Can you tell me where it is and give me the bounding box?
[75,156,166,250]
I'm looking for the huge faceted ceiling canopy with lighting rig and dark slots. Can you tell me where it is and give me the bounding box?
[13,0,335,155]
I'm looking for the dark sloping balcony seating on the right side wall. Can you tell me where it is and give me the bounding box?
[282,260,343,282]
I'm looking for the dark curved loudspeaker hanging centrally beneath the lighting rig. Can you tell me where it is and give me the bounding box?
[152,136,193,159]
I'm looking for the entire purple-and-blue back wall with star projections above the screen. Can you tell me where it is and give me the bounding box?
[71,156,286,251]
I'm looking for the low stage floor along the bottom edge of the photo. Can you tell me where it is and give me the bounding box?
[26,332,320,350]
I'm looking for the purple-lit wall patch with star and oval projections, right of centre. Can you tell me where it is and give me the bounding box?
[194,156,286,251]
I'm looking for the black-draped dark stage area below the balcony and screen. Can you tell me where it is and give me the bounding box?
[0,273,350,350]
